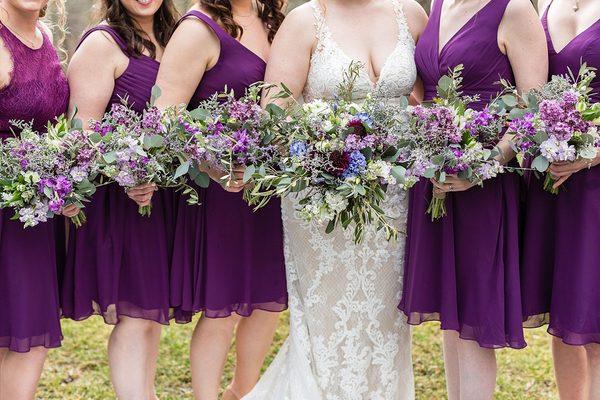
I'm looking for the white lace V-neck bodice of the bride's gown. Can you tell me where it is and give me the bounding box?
[303,0,417,101]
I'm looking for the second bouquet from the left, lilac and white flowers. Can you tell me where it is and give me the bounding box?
[89,103,182,216]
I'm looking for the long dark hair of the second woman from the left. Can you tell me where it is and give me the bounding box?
[98,0,179,58]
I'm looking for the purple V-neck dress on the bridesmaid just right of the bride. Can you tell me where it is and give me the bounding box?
[399,0,526,348]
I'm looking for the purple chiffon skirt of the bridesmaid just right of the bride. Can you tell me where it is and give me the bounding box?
[399,174,526,348]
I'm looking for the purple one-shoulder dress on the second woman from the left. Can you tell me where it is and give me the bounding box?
[61,25,173,324]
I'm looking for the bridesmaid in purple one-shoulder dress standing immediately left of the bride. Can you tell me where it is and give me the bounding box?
[157,0,287,400]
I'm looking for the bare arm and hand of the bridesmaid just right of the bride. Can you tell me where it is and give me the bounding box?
[432,0,548,192]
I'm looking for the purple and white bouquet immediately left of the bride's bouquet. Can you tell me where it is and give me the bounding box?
[165,85,285,203]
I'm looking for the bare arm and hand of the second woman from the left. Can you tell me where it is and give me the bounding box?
[63,31,156,209]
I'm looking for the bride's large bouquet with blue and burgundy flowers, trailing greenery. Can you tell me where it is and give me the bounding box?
[247,92,416,243]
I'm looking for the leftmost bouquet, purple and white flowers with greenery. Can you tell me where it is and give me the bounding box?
[0,116,98,227]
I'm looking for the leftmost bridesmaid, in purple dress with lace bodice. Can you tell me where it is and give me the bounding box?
[0,0,69,400]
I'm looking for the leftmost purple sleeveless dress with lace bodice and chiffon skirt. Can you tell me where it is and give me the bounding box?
[0,24,69,352]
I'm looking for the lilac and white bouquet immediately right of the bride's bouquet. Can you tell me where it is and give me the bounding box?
[410,66,504,220]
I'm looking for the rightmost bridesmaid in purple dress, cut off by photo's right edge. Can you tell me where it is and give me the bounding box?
[522,0,600,400]
